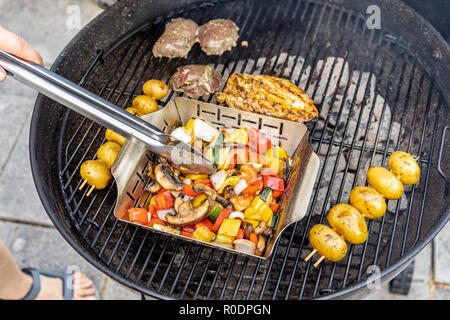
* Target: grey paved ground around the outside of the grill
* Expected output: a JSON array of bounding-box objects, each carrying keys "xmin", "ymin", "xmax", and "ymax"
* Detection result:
[{"xmin": 0, "ymin": 0, "xmax": 450, "ymax": 299}]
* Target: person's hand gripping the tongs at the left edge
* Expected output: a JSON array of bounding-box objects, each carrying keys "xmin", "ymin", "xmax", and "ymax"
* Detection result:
[{"xmin": 0, "ymin": 24, "xmax": 42, "ymax": 82}]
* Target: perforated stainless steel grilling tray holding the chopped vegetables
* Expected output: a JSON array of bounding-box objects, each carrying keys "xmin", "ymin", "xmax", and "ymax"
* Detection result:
[{"xmin": 111, "ymin": 98, "xmax": 320, "ymax": 259}]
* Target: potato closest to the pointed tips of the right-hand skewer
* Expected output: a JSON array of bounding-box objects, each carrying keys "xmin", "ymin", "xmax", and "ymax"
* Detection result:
[{"xmin": 309, "ymin": 224, "xmax": 347, "ymax": 261}]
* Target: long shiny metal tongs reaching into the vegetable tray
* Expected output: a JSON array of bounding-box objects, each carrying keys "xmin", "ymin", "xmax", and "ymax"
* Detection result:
[{"xmin": 0, "ymin": 50, "xmax": 215, "ymax": 174}]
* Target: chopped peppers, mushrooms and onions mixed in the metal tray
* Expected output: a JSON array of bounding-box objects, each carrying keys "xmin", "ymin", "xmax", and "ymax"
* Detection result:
[{"xmin": 129, "ymin": 119, "xmax": 289, "ymax": 255}]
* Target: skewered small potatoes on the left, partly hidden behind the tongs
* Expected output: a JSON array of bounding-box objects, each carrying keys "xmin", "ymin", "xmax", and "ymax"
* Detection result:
[{"xmin": 79, "ymin": 79, "xmax": 168, "ymax": 196}]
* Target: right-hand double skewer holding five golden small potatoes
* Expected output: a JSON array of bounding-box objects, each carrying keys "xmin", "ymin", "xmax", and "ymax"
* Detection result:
[{"xmin": 305, "ymin": 151, "xmax": 420, "ymax": 267}]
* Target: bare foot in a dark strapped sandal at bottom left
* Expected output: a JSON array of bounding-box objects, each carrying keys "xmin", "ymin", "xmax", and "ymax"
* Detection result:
[{"xmin": 31, "ymin": 272, "xmax": 96, "ymax": 300}]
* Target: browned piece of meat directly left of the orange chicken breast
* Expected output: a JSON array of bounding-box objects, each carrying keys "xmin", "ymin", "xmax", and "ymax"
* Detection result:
[{"xmin": 169, "ymin": 64, "xmax": 222, "ymax": 99}]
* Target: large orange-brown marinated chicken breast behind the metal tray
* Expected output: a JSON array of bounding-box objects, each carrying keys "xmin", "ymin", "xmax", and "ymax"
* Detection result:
[{"xmin": 216, "ymin": 73, "xmax": 318, "ymax": 122}]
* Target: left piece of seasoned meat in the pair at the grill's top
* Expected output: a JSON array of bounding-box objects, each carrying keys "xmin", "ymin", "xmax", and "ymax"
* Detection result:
[{"xmin": 153, "ymin": 18, "xmax": 198, "ymax": 58}]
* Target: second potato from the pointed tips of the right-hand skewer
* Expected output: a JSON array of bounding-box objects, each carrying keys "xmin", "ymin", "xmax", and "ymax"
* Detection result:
[{"xmin": 327, "ymin": 203, "xmax": 367, "ymax": 244}]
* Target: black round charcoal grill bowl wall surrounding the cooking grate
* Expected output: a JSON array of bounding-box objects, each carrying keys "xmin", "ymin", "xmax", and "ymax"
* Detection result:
[{"xmin": 30, "ymin": 0, "xmax": 450, "ymax": 299}]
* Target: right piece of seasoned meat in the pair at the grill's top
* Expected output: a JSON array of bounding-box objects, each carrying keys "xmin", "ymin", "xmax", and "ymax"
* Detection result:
[{"xmin": 197, "ymin": 19, "xmax": 239, "ymax": 55}]
